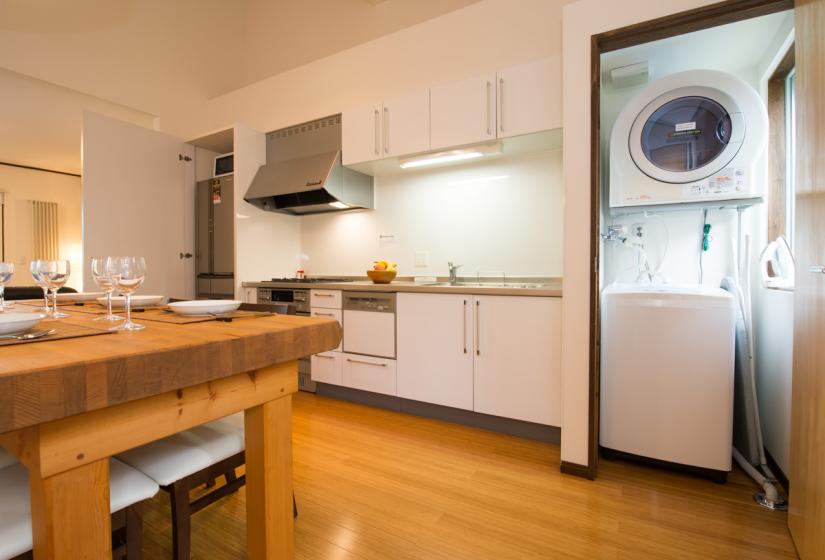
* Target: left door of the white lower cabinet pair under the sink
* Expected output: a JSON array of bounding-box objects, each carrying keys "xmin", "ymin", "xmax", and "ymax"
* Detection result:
[{"xmin": 397, "ymin": 293, "xmax": 473, "ymax": 410}]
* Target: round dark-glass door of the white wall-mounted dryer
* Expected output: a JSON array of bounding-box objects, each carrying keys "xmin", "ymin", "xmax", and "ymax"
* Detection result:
[{"xmin": 628, "ymin": 87, "xmax": 745, "ymax": 183}]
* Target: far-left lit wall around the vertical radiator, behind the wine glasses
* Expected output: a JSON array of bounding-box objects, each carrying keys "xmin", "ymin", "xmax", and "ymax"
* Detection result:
[{"xmin": 0, "ymin": 165, "xmax": 83, "ymax": 290}]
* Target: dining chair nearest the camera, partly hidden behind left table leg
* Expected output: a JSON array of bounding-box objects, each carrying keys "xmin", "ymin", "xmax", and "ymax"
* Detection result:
[{"xmin": 0, "ymin": 456, "xmax": 158, "ymax": 560}]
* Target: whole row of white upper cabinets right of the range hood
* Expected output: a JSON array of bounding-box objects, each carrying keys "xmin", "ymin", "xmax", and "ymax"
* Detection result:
[{"xmin": 343, "ymin": 56, "xmax": 562, "ymax": 165}]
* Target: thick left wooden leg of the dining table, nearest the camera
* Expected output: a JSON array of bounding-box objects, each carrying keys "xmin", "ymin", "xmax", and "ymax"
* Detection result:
[{"xmin": 29, "ymin": 459, "xmax": 112, "ymax": 560}]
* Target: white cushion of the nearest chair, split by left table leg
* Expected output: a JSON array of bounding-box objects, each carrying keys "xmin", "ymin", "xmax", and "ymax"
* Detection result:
[{"xmin": 0, "ymin": 459, "xmax": 158, "ymax": 560}]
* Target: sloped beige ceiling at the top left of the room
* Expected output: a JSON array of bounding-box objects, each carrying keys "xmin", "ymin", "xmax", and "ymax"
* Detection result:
[{"xmin": 0, "ymin": 0, "xmax": 479, "ymax": 172}]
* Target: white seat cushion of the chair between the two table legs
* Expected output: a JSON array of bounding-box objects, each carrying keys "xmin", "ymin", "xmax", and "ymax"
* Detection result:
[{"xmin": 118, "ymin": 413, "xmax": 244, "ymax": 486}]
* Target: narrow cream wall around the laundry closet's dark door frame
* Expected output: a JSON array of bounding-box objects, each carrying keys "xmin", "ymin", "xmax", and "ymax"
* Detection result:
[{"xmin": 561, "ymin": 0, "xmax": 713, "ymax": 465}]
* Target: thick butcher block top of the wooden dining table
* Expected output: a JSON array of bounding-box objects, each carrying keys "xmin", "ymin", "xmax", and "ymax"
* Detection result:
[{"xmin": 0, "ymin": 307, "xmax": 341, "ymax": 434}]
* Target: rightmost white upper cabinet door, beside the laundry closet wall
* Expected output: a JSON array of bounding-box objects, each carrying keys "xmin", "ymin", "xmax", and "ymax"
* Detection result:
[{"xmin": 496, "ymin": 56, "xmax": 562, "ymax": 138}]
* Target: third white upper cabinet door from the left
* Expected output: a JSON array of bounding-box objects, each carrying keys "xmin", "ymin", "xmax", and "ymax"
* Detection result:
[{"xmin": 430, "ymin": 74, "xmax": 496, "ymax": 150}]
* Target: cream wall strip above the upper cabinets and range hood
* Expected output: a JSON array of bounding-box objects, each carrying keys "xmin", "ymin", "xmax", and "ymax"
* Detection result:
[{"xmin": 179, "ymin": 0, "xmax": 569, "ymax": 138}]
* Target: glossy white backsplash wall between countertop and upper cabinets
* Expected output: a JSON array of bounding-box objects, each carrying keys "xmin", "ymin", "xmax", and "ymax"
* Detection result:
[{"xmin": 301, "ymin": 150, "xmax": 564, "ymax": 277}]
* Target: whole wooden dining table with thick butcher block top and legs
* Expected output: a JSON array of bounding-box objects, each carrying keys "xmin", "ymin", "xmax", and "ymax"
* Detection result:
[{"xmin": 0, "ymin": 306, "xmax": 341, "ymax": 560}]
